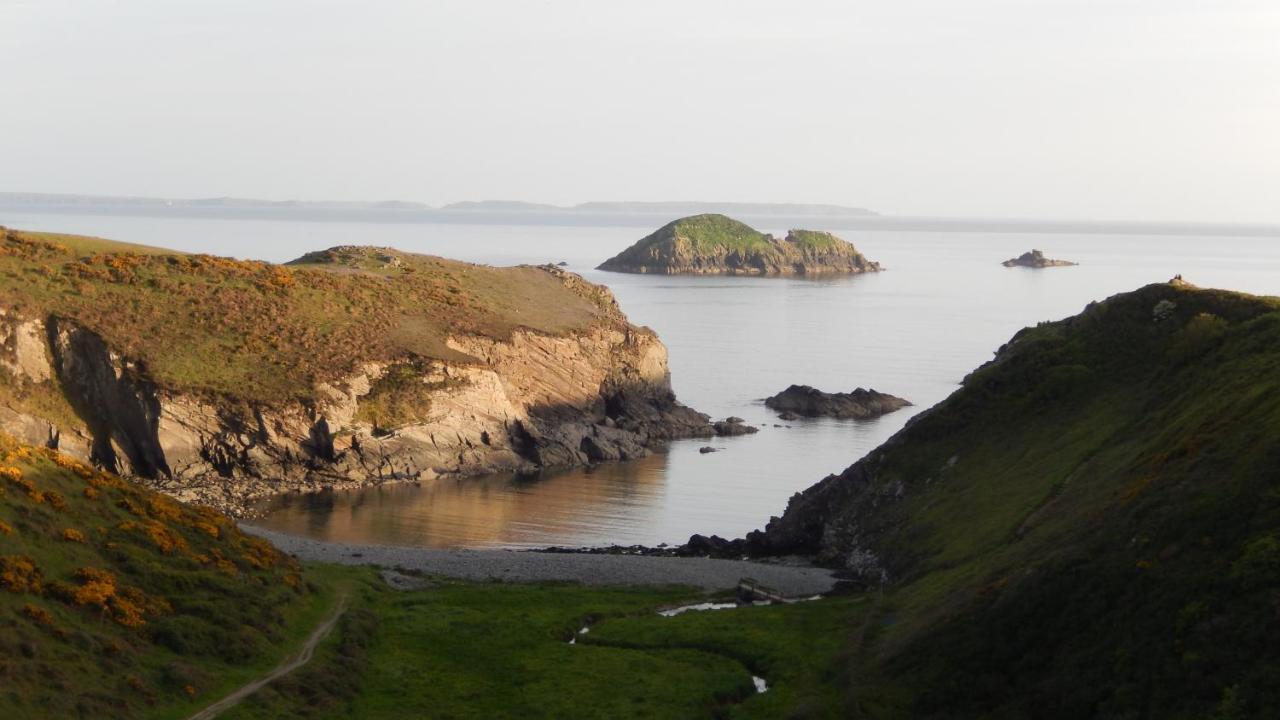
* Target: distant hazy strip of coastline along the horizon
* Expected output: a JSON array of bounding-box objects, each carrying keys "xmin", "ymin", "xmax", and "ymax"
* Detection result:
[{"xmin": 0, "ymin": 192, "xmax": 1280, "ymax": 238}]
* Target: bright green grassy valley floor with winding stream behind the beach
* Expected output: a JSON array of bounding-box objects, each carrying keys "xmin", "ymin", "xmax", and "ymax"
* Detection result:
[{"xmin": 227, "ymin": 570, "xmax": 864, "ymax": 720}]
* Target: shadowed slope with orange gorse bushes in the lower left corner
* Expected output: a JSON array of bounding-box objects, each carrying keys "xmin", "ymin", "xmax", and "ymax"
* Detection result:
[{"xmin": 0, "ymin": 427, "xmax": 329, "ymax": 719}]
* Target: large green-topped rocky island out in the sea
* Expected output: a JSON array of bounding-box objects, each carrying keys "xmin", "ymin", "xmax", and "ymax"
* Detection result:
[{"xmin": 596, "ymin": 214, "xmax": 881, "ymax": 275}]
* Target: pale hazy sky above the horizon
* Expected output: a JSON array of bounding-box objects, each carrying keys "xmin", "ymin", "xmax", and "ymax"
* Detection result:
[{"xmin": 0, "ymin": 0, "xmax": 1280, "ymax": 222}]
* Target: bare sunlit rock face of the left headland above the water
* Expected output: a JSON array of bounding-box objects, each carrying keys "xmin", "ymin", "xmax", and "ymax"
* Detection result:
[{"xmin": 0, "ymin": 249, "xmax": 716, "ymax": 512}]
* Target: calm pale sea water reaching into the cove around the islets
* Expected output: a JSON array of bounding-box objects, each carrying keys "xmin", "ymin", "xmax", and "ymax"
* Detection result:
[{"xmin": 0, "ymin": 213, "xmax": 1280, "ymax": 547}]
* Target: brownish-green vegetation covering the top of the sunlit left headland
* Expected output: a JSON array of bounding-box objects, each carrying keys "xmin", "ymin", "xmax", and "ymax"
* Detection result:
[{"xmin": 0, "ymin": 229, "xmax": 614, "ymax": 399}]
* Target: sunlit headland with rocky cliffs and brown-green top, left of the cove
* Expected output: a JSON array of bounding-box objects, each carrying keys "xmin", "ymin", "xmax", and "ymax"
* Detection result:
[{"xmin": 0, "ymin": 231, "xmax": 714, "ymax": 511}]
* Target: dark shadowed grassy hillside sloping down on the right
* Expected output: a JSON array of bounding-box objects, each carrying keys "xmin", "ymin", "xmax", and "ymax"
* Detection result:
[{"xmin": 749, "ymin": 282, "xmax": 1280, "ymax": 717}]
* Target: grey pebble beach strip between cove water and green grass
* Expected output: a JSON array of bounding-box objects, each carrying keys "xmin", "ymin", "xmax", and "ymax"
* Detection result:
[{"xmin": 241, "ymin": 523, "xmax": 836, "ymax": 597}]
